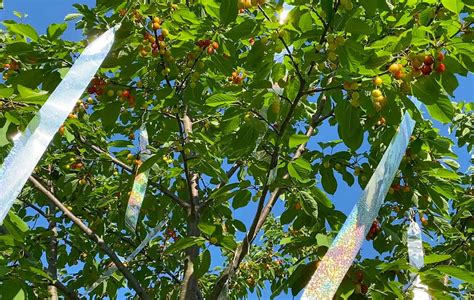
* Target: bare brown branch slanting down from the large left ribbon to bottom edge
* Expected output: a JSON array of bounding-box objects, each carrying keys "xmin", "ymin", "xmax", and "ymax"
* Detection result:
[{"xmin": 29, "ymin": 176, "xmax": 152, "ymax": 300}]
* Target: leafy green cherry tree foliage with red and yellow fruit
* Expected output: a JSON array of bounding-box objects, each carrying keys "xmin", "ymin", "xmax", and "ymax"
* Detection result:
[{"xmin": 0, "ymin": 0, "xmax": 474, "ymax": 299}]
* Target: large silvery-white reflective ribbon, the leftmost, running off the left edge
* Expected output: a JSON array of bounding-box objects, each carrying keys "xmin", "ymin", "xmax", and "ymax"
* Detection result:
[{"xmin": 0, "ymin": 25, "xmax": 120, "ymax": 224}]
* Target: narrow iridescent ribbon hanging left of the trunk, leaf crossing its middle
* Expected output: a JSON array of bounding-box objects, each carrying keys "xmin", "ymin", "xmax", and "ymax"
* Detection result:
[{"xmin": 125, "ymin": 125, "xmax": 151, "ymax": 231}]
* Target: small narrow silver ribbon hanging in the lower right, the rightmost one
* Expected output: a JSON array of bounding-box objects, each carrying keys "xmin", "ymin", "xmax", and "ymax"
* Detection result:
[{"xmin": 407, "ymin": 220, "xmax": 431, "ymax": 300}]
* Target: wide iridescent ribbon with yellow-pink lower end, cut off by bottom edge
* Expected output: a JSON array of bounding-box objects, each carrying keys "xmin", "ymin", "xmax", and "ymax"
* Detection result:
[{"xmin": 301, "ymin": 113, "xmax": 415, "ymax": 300}]
